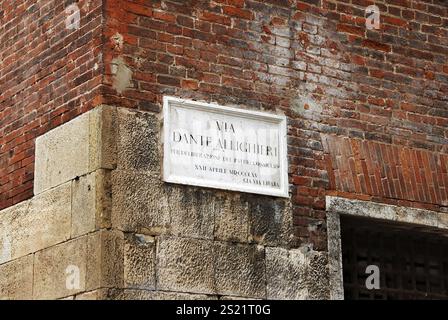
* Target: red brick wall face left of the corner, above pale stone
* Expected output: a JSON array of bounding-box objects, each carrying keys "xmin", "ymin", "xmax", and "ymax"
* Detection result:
[{"xmin": 0, "ymin": 0, "xmax": 103, "ymax": 209}]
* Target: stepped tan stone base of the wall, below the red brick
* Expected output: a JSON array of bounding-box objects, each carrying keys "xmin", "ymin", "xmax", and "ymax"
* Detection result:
[{"xmin": 0, "ymin": 106, "xmax": 329, "ymax": 299}]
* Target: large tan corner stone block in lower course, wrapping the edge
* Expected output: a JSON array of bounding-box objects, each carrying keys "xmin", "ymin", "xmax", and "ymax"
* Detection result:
[{"xmin": 34, "ymin": 230, "xmax": 123, "ymax": 299}]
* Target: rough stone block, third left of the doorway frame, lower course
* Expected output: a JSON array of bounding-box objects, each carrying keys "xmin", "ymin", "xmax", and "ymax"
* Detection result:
[{"xmin": 156, "ymin": 238, "xmax": 216, "ymax": 294}]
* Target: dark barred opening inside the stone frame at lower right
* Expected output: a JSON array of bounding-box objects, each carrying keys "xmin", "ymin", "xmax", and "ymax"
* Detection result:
[{"xmin": 341, "ymin": 216, "xmax": 448, "ymax": 300}]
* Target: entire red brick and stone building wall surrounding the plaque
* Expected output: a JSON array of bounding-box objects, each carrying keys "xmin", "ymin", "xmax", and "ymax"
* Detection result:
[{"xmin": 0, "ymin": 0, "xmax": 448, "ymax": 299}]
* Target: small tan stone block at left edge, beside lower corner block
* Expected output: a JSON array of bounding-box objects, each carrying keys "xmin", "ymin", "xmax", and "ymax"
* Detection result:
[{"xmin": 0, "ymin": 254, "xmax": 33, "ymax": 300}]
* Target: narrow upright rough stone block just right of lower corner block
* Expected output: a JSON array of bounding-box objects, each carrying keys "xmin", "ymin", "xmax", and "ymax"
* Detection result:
[{"xmin": 124, "ymin": 234, "xmax": 156, "ymax": 290}]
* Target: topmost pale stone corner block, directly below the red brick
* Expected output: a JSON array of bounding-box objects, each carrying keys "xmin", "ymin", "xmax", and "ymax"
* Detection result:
[{"xmin": 34, "ymin": 106, "xmax": 116, "ymax": 194}]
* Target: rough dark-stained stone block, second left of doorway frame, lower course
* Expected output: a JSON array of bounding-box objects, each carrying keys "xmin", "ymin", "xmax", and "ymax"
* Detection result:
[{"xmin": 214, "ymin": 242, "xmax": 266, "ymax": 298}]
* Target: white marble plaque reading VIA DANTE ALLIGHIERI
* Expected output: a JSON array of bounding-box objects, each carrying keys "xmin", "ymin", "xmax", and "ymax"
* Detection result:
[{"xmin": 163, "ymin": 97, "xmax": 288, "ymax": 197}]
